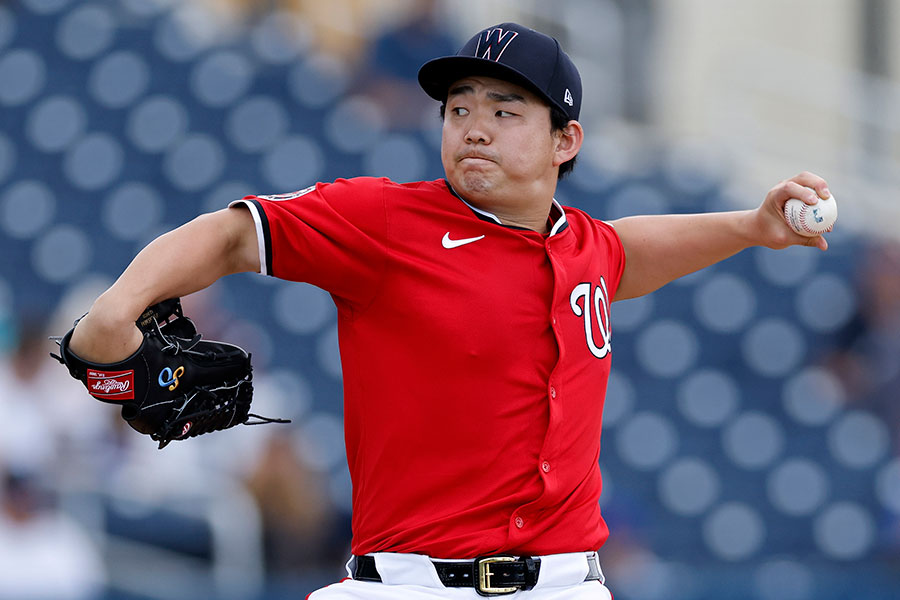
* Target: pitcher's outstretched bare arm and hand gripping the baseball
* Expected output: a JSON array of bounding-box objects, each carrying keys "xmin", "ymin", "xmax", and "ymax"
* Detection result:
[{"xmin": 611, "ymin": 173, "xmax": 830, "ymax": 300}]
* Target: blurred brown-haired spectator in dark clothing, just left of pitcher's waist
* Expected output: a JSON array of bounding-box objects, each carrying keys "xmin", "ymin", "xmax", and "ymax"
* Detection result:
[{"xmin": 246, "ymin": 431, "xmax": 349, "ymax": 575}]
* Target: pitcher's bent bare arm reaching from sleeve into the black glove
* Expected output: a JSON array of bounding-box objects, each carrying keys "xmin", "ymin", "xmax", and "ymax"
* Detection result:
[{"xmin": 70, "ymin": 205, "xmax": 260, "ymax": 363}]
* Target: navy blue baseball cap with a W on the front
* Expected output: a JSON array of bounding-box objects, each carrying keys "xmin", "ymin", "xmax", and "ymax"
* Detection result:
[{"xmin": 419, "ymin": 23, "xmax": 581, "ymax": 120}]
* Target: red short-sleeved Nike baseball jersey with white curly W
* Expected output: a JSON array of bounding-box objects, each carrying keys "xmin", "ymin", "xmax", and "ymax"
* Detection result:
[{"xmin": 232, "ymin": 178, "xmax": 625, "ymax": 558}]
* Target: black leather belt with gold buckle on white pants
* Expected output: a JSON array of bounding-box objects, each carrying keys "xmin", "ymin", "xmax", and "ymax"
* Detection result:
[{"xmin": 351, "ymin": 555, "xmax": 603, "ymax": 596}]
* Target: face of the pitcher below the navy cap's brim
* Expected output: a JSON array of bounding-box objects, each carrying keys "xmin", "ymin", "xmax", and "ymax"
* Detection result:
[{"xmin": 441, "ymin": 76, "xmax": 558, "ymax": 210}]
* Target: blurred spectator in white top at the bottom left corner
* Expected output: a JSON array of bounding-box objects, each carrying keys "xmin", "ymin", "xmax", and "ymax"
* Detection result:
[{"xmin": 0, "ymin": 469, "xmax": 105, "ymax": 600}]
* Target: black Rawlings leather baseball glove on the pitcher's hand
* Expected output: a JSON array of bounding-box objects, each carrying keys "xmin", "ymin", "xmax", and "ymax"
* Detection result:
[{"xmin": 51, "ymin": 298, "xmax": 290, "ymax": 450}]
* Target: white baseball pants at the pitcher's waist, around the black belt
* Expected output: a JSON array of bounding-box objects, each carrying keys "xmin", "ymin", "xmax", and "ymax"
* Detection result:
[{"xmin": 307, "ymin": 552, "xmax": 612, "ymax": 600}]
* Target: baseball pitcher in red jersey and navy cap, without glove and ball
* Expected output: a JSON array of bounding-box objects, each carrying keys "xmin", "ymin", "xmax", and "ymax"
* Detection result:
[{"xmin": 70, "ymin": 23, "xmax": 829, "ymax": 600}]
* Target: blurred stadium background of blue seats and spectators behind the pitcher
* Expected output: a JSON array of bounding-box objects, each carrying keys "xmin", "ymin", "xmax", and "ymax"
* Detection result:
[{"xmin": 0, "ymin": 0, "xmax": 900, "ymax": 600}]
